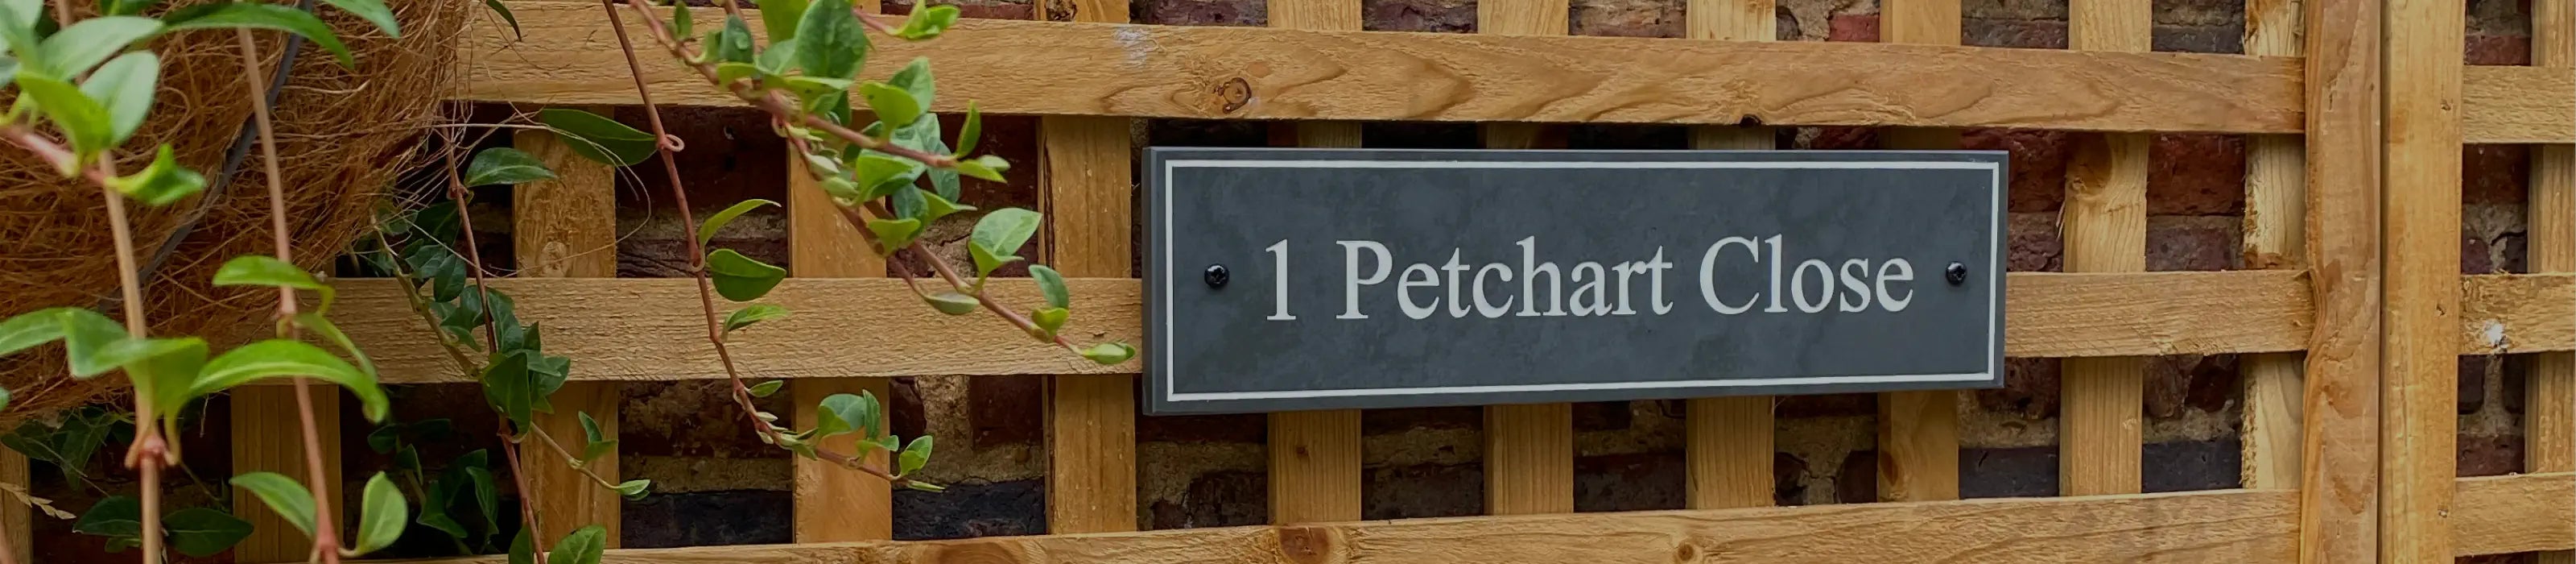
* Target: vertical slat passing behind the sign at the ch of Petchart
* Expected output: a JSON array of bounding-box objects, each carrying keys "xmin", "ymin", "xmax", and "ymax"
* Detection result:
[{"xmin": 1476, "ymin": 0, "xmax": 1574, "ymax": 515}]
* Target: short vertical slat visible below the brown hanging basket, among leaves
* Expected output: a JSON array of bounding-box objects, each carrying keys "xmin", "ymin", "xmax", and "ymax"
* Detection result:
[{"xmin": 232, "ymin": 384, "xmax": 353, "ymax": 564}]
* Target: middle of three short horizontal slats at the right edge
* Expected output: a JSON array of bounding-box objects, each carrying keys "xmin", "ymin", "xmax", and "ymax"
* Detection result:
[{"xmin": 2460, "ymin": 273, "xmax": 2576, "ymax": 355}]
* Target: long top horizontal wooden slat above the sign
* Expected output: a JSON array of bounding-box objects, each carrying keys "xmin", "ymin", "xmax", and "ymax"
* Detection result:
[{"xmin": 459, "ymin": 0, "xmax": 2303, "ymax": 134}]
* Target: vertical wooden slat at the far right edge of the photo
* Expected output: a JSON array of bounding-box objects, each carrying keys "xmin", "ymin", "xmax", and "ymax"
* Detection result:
[{"xmin": 2522, "ymin": 0, "xmax": 2576, "ymax": 564}]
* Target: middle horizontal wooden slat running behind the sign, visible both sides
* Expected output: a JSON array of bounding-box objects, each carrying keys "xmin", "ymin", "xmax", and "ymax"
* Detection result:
[{"xmin": 312, "ymin": 271, "xmax": 2310, "ymax": 384}]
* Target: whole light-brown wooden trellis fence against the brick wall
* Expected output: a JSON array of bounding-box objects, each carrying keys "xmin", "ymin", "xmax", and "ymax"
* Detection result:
[{"xmin": 13, "ymin": 0, "xmax": 2576, "ymax": 564}]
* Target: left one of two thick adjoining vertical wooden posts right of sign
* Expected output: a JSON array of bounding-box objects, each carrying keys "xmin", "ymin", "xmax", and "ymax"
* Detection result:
[{"xmin": 2297, "ymin": 0, "xmax": 2383, "ymax": 556}]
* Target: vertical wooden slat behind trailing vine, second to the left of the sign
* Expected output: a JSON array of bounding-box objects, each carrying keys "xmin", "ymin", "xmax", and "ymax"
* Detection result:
[{"xmin": 782, "ymin": 155, "xmax": 894, "ymax": 543}]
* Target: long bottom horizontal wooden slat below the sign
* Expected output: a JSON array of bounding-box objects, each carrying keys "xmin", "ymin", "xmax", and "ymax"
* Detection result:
[{"xmin": 368, "ymin": 489, "xmax": 2297, "ymax": 564}]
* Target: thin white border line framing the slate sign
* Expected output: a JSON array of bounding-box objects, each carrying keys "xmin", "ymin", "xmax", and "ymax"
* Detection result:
[{"xmin": 1154, "ymin": 160, "xmax": 2004, "ymax": 402}]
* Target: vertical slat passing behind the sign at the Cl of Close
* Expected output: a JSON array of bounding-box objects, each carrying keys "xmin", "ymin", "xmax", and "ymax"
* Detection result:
[{"xmin": 1682, "ymin": 0, "xmax": 1780, "ymax": 510}]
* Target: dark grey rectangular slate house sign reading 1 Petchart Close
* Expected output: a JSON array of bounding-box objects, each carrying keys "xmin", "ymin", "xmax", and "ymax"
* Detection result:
[{"xmin": 1144, "ymin": 147, "xmax": 2007, "ymax": 415}]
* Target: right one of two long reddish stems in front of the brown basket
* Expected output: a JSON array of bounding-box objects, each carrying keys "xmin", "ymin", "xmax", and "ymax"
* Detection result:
[{"xmin": 232, "ymin": 28, "xmax": 340, "ymax": 564}]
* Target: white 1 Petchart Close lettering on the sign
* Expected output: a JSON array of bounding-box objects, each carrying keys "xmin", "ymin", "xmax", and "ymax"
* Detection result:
[{"xmin": 1288, "ymin": 234, "xmax": 1914, "ymax": 322}]
